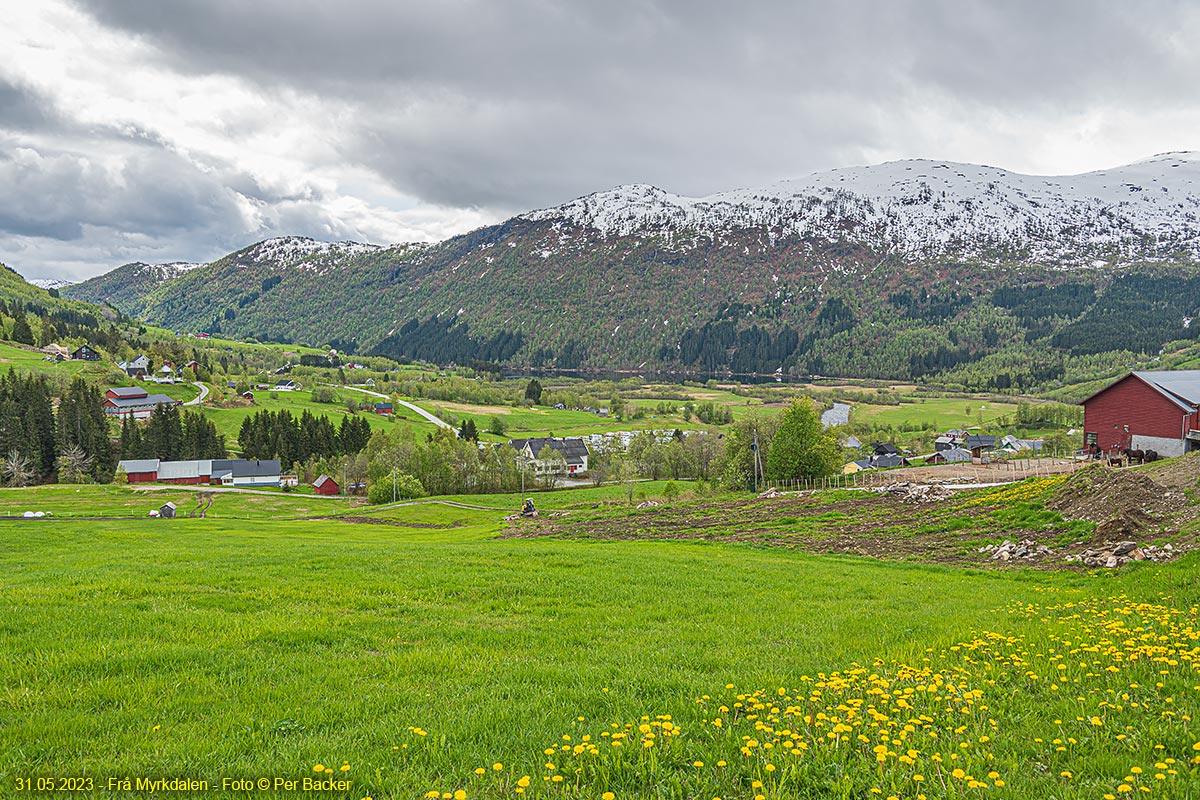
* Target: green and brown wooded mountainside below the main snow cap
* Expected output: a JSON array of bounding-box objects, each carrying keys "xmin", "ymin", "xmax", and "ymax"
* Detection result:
[{"xmin": 67, "ymin": 226, "xmax": 1200, "ymax": 391}]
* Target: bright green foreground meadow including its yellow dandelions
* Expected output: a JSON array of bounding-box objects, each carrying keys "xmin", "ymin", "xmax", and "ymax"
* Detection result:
[{"xmin": 0, "ymin": 487, "xmax": 1200, "ymax": 800}]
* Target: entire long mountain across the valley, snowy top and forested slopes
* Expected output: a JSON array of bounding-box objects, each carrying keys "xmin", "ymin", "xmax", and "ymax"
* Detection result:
[{"xmin": 64, "ymin": 154, "xmax": 1200, "ymax": 385}]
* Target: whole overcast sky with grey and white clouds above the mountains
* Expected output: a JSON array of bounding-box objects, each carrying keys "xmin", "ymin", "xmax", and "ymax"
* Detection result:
[{"xmin": 0, "ymin": 0, "xmax": 1200, "ymax": 279}]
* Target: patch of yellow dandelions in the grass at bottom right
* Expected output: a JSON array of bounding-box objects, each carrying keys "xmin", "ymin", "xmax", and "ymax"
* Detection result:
[{"xmin": 415, "ymin": 596, "xmax": 1200, "ymax": 800}]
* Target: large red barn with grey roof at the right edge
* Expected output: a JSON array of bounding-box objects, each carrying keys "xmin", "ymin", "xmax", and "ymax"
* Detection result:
[{"xmin": 1084, "ymin": 369, "xmax": 1200, "ymax": 456}]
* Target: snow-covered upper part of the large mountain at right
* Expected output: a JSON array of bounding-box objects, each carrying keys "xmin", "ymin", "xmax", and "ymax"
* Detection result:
[{"xmin": 523, "ymin": 152, "xmax": 1200, "ymax": 265}]
